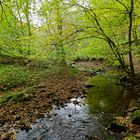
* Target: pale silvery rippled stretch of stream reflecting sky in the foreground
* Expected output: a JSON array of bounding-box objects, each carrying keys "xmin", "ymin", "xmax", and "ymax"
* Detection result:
[{"xmin": 17, "ymin": 98, "xmax": 118, "ymax": 140}]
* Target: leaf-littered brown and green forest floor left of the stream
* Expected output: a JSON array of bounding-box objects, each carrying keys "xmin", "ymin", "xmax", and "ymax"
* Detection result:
[{"xmin": 0, "ymin": 56, "xmax": 140, "ymax": 140}]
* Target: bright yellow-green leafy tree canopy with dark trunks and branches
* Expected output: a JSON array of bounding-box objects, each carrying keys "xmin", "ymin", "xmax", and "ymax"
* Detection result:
[{"xmin": 0, "ymin": 0, "xmax": 140, "ymax": 74}]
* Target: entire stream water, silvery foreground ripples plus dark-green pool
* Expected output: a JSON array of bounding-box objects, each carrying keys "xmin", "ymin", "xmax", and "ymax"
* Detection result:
[{"xmin": 17, "ymin": 76, "xmax": 130, "ymax": 140}]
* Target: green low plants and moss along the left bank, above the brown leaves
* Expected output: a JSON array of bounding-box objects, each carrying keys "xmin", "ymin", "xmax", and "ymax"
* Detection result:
[{"xmin": 0, "ymin": 64, "xmax": 78, "ymax": 103}]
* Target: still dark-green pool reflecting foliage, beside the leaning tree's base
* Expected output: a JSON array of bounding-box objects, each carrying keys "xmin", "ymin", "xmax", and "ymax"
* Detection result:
[{"xmin": 86, "ymin": 76, "xmax": 131, "ymax": 115}]
